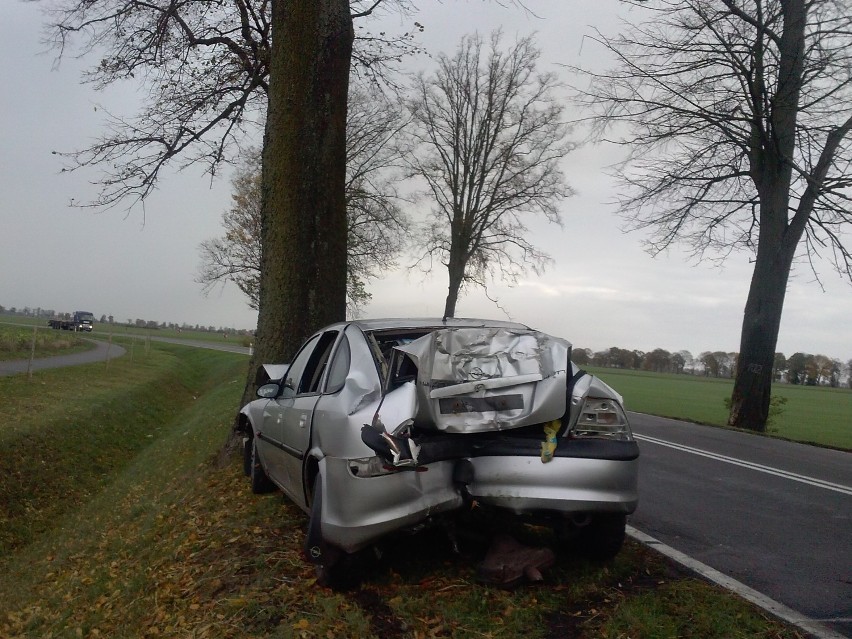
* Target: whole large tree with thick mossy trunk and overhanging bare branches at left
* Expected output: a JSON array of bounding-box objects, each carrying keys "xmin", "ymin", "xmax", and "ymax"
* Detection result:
[{"xmin": 42, "ymin": 0, "xmax": 420, "ymax": 412}]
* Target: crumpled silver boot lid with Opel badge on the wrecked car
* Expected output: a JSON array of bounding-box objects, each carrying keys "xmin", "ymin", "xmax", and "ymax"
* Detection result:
[{"xmin": 396, "ymin": 327, "xmax": 571, "ymax": 433}]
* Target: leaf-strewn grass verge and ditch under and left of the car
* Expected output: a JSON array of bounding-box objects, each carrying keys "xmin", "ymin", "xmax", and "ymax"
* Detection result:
[{"xmin": 0, "ymin": 344, "xmax": 802, "ymax": 639}]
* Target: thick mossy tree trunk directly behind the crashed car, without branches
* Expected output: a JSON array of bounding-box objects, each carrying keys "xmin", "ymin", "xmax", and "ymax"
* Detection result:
[{"xmin": 238, "ymin": 0, "xmax": 354, "ymax": 410}]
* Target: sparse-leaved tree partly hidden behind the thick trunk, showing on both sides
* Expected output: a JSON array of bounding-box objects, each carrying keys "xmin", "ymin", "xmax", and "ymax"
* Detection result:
[{"xmin": 196, "ymin": 89, "xmax": 408, "ymax": 313}]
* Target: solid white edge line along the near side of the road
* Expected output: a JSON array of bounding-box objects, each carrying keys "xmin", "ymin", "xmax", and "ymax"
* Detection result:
[{"xmin": 627, "ymin": 526, "xmax": 846, "ymax": 639}]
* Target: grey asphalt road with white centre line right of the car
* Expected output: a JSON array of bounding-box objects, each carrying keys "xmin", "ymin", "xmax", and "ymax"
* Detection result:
[{"xmin": 630, "ymin": 413, "xmax": 852, "ymax": 637}]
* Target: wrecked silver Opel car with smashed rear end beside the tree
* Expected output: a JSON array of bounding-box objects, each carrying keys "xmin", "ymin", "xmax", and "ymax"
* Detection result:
[{"xmin": 238, "ymin": 319, "xmax": 639, "ymax": 581}]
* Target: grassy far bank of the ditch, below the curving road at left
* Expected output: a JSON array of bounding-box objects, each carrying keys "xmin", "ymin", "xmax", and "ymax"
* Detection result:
[{"xmin": 0, "ymin": 345, "xmax": 250, "ymax": 555}]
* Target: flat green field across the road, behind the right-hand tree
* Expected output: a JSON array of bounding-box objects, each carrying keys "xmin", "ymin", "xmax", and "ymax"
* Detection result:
[{"xmin": 586, "ymin": 367, "xmax": 852, "ymax": 450}]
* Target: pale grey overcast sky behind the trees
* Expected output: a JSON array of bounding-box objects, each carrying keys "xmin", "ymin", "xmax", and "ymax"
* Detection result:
[{"xmin": 0, "ymin": 0, "xmax": 852, "ymax": 362}]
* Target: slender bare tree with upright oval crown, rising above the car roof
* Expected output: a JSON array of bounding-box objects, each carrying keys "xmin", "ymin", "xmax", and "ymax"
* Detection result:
[{"xmin": 407, "ymin": 31, "xmax": 571, "ymax": 317}]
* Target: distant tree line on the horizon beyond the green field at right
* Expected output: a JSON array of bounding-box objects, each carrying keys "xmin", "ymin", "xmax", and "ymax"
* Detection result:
[{"xmin": 571, "ymin": 346, "xmax": 852, "ymax": 388}]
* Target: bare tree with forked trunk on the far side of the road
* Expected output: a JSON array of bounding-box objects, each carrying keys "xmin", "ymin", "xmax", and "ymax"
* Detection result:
[{"xmin": 582, "ymin": 0, "xmax": 852, "ymax": 430}]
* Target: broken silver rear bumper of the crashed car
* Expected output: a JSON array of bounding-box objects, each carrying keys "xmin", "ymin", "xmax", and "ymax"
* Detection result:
[{"xmin": 320, "ymin": 444, "xmax": 638, "ymax": 552}]
